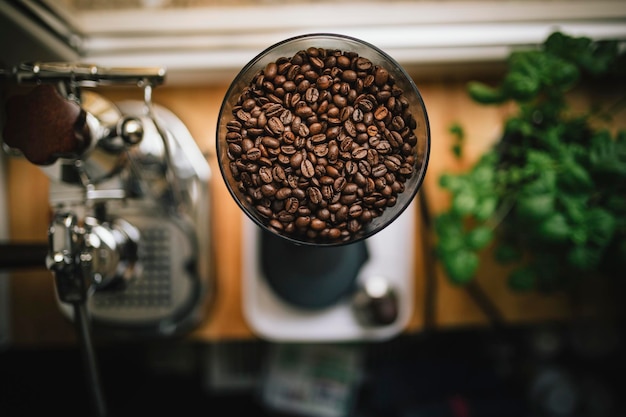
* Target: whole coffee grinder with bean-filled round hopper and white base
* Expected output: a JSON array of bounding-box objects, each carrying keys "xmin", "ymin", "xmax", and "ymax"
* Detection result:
[{"xmin": 217, "ymin": 33, "xmax": 430, "ymax": 341}]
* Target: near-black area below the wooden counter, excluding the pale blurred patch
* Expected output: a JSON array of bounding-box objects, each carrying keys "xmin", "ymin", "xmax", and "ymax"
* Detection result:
[{"xmin": 0, "ymin": 321, "xmax": 626, "ymax": 417}]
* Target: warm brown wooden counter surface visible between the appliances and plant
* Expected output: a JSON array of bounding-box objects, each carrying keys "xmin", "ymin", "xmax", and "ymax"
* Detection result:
[{"xmin": 7, "ymin": 82, "xmax": 578, "ymax": 346}]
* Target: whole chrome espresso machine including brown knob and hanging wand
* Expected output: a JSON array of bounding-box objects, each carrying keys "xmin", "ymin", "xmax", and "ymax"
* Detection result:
[{"xmin": 2, "ymin": 62, "xmax": 214, "ymax": 416}]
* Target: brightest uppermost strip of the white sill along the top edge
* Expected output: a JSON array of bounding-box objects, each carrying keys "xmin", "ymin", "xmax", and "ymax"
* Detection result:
[{"xmin": 75, "ymin": 0, "xmax": 626, "ymax": 35}]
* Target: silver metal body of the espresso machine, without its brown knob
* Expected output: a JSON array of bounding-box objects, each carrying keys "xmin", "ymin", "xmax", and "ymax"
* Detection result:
[{"xmin": 4, "ymin": 63, "xmax": 213, "ymax": 337}]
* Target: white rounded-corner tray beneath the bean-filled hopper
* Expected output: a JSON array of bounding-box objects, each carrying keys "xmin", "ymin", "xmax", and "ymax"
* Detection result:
[{"xmin": 241, "ymin": 200, "xmax": 416, "ymax": 342}]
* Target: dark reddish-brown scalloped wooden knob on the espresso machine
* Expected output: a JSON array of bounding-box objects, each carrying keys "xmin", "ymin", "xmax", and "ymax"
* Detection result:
[{"xmin": 3, "ymin": 84, "xmax": 91, "ymax": 165}]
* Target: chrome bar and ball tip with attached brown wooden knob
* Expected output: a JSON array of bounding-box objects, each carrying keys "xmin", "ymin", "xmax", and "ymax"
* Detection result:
[{"xmin": 0, "ymin": 62, "xmax": 161, "ymax": 165}]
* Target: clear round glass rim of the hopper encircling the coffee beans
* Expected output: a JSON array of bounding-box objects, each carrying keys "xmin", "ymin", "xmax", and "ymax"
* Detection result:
[{"xmin": 215, "ymin": 32, "xmax": 431, "ymax": 247}]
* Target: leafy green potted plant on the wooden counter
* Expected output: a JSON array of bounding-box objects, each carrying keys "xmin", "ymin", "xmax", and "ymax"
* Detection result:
[{"xmin": 435, "ymin": 32, "xmax": 626, "ymax": 291}]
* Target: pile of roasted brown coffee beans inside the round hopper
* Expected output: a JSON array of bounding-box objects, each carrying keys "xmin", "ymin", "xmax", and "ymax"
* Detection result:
[{"xmin": 226, "ymin": 47, "xmax": 418, "ymax": 243}]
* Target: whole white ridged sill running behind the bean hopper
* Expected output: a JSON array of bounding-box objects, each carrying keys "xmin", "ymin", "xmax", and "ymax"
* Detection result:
[{"xmin": 24, "ymin": 0, "xmax": 626, "ymax": 84}]
